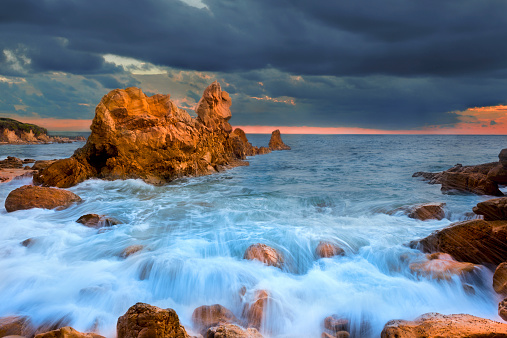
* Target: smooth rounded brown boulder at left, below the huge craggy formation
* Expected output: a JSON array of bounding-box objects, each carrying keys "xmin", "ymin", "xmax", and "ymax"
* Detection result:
[{"xmin": 5, "ymin": 185, "xmax": 81, "ymax": 212}]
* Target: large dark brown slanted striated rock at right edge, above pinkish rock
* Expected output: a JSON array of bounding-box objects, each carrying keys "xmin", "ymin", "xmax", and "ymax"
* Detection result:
[{"xmin": 410, "ymin": 219, "xmax": 507, "ymax": 265}]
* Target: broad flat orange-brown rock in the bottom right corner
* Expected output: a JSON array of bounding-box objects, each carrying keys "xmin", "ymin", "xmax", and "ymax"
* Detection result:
[{"xmin": 381, "ymin": 313, "xmax": 507, "ymax": 338}]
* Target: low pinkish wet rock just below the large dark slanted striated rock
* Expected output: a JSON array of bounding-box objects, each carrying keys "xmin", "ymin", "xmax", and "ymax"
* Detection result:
[{"xmin": 409, "ymin": 252, "xmax": 476, "ymax": 280}]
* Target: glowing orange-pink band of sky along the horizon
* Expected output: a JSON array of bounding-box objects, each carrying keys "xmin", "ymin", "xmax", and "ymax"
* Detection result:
[{"xmin": 9, "ymin": 105, "xmax": 507, "ymax": 135}]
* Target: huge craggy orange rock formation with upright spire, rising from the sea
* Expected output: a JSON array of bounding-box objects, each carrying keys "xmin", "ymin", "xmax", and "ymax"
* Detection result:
[{"xmin": 34, "ymin": 81, "xmax": 278, "ymax": 188}]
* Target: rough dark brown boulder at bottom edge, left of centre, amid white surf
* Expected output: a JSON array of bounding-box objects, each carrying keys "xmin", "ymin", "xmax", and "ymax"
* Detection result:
[{"xmin": 116, "ymin": 303, "xmax": 189, "ymax": 338}]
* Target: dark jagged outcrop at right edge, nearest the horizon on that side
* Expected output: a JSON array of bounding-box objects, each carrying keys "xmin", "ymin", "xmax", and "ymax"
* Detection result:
[{"xmin": 412, "ymin": 149, "xmax": 507, "ymax": 196}]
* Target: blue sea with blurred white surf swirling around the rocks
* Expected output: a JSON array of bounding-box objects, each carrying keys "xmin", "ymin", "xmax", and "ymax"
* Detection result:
[{"xmin": 0, "ymin": 135, "xmax": 507, "ymax": 337}]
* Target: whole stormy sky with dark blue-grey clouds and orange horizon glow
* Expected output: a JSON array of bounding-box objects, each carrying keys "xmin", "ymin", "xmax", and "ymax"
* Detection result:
[{"xmin": 0, "ymin": 0, "xmax": 507, "ymax": 134}]
